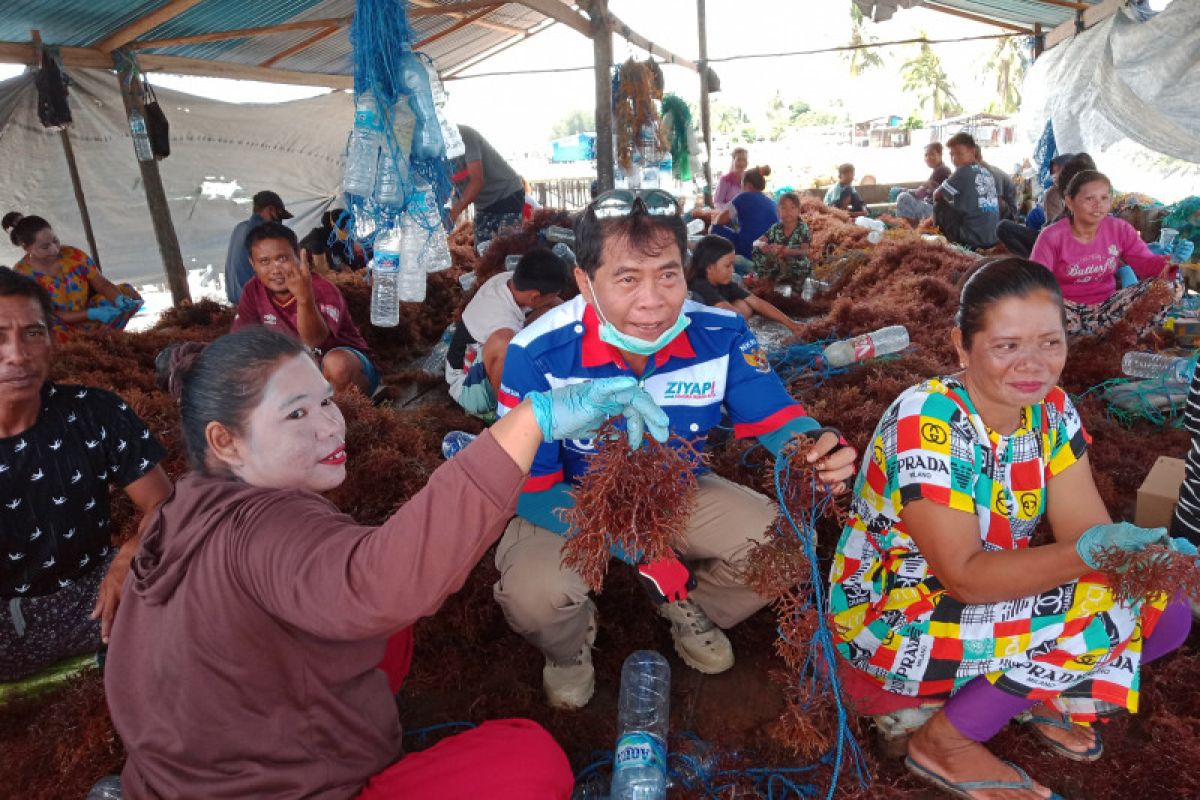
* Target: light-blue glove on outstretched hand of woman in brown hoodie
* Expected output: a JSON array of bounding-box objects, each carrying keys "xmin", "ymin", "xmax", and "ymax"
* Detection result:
[{"xmin": 529, "ymin": 375, "xmax": 670, "ymax": 450}]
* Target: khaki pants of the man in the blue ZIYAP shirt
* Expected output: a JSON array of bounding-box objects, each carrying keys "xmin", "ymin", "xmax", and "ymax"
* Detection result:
[{"xmin": 494, "ymin": 474, "xmax": 776, "ymax": 661}]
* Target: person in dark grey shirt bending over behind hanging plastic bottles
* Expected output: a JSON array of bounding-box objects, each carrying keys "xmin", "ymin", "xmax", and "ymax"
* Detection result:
[{"xmin": 450, "ymin": 125, "xmax": 524, "ymax": 247}]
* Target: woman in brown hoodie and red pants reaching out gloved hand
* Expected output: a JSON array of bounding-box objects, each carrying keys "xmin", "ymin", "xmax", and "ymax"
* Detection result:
[{"xmin": 104, "ymin": 327, "xmax": 667, "ymax": 800}]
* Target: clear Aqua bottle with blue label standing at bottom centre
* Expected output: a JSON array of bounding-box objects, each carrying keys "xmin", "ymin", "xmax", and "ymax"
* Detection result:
[{"xmin": 610, "ymin": 650, "xmax": 671, "ymax": 800}]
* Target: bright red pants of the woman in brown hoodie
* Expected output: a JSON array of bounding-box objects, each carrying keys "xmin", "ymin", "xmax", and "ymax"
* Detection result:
[{"xmin": 356, "ymin": 720, "xmax": 575, "ymax": 800}]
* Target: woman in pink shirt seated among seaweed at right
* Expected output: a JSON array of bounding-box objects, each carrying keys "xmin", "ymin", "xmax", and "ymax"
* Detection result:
[{"xmin": 1030, "ymin": 169, "xmax": 1170, "ymax": 336}]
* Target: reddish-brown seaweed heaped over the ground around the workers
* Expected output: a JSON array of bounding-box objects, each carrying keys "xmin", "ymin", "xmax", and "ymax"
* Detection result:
[{"xmin": 0, "ymin": 209, "xmax": 1200, "ymax": 800}]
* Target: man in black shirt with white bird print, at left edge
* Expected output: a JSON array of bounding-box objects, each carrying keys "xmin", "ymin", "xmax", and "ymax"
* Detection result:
[{"xmin": 0, "ymin": 267, "xmax": 170, "ymax": 682}]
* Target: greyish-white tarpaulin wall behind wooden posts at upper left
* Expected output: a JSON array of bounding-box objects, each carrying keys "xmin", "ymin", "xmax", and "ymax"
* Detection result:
[{"xmin": 0, "ymin": 70, "xmax": 354, "ymax": 283}]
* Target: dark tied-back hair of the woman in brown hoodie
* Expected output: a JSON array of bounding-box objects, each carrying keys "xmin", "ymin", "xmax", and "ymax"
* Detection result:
[{"xmin": 166, "ymin": 325, "xmax": 308, "ymax": 475}]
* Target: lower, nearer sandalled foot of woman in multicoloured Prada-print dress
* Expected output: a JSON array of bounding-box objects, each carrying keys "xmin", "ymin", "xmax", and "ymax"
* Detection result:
[{"xmin": 908, "ymin": 711, "xmax": 1052, "ymax": 800}]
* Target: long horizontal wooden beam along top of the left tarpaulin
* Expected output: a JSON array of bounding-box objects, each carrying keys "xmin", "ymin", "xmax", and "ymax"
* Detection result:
[{"xmin": 0, "ymin": 42, "xmax": 354, "ymax": 89}]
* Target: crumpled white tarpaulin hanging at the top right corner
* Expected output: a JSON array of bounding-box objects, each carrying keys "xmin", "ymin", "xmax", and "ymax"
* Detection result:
[{"xmin": 1021, "ymin": 0, "xmax": 1200, "ymax": 162}]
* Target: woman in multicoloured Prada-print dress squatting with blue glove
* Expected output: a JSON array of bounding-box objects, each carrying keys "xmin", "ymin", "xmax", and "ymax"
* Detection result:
[{"xmin": 830, "ymin": 258, "xmax": 1192, "ymax": 800}]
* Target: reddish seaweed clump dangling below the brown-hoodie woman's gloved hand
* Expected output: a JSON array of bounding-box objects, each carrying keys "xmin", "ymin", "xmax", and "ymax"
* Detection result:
[{"xmin": 563, "ymin": 422, "xmax": 703, "ymax": 591}]
